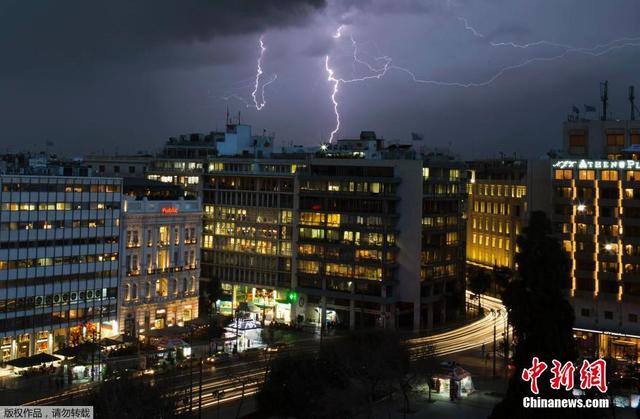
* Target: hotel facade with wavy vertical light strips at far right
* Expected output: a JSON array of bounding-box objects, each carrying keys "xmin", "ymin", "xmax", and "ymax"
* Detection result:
[{"xmin": 552, "ymin": 159, "xmax": 640, "ymax": 362}]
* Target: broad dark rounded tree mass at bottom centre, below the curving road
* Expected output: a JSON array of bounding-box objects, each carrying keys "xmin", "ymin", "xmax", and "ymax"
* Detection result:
[{"xmin": 257, "ymin": 330, "xmax": 410, "ymax": 419}]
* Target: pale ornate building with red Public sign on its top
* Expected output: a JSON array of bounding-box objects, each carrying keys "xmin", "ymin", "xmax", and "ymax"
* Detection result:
[{"xmin": 118, "ymin": 195, "xmax": 202, "ymax": 336}]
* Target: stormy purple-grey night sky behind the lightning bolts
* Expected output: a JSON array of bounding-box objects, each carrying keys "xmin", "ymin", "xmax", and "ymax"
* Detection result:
[{"xmin": 0, "ymin": 0, "xmax": 640, "ymax": 157}]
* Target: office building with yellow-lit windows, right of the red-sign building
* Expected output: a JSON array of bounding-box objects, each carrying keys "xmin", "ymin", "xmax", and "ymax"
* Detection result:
[{"xmin": 202, "ymin": 157, "xmax": 298, "ymax": 322}]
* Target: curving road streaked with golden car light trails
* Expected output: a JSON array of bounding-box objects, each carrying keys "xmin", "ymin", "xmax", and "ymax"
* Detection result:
[{"xmin": 26, "ymin": 293, "xmax": 506, "ymax": 410}]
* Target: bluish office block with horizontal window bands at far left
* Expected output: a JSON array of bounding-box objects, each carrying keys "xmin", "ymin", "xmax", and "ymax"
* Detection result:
[{"xmin": 0, "ymin": 175, "xmax": 122, "ymax": 361}]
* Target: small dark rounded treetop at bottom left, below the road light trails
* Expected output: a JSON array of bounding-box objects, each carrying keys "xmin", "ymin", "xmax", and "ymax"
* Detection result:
[{"xmin": 90, "ymin": 377, "xmax": 176, "ymax": 419}]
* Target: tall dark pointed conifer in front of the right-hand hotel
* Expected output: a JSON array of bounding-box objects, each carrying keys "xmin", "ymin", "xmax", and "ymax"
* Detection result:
[{"xmin": 490, "ymin": 212, "xmax": 587, "ymax": 419}]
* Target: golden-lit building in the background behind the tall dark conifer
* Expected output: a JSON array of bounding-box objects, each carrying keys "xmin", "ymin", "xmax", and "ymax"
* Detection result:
[{"xmin": 467, "ymin": 157, "xmax": 551, "ymax": 270}]
